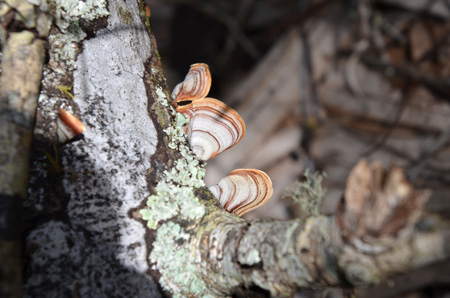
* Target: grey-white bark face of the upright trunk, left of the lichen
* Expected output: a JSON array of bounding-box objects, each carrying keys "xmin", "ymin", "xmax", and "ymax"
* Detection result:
[{"xmin": 24, "ymin": 1, "xmax": 159, "ymax": 297}]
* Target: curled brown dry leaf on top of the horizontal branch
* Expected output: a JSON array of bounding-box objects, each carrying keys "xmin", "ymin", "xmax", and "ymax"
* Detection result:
[{"xmin": 338, "ymin": 160, "xmax": 431, "ymax": 240}]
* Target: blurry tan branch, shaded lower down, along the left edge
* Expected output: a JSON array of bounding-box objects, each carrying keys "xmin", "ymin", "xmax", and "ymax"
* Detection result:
[{"xmin": 0, "ymin": 3, "xmax": 49, "ymax": 297}]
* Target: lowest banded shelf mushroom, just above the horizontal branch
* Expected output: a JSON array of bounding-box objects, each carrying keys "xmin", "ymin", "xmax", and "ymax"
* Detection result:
[{"xmin": 209, "ymin": 169, "xmax": 273, "ymax": 215}]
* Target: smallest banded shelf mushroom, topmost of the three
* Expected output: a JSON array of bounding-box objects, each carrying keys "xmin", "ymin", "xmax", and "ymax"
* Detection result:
[{"xmin": 172, "ymin": 63, "xmax": 211, "ymax": 104}]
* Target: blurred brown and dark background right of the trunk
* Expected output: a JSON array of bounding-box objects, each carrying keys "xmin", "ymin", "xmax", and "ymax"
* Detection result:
[{"xmin": 147, "ymin": 0, "xmax": 450, "ymax": 297}]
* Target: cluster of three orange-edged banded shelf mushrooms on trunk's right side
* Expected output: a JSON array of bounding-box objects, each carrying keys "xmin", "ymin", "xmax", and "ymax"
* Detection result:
[{"xmin": 172, "ymin": 63, "xmax": 273, "ymax": 215}]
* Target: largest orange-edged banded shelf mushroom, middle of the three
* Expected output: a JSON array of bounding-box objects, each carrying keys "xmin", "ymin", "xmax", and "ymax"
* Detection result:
[{"xmin": 177, "ymin": 98, "xmax": 245, "ymax": 160}]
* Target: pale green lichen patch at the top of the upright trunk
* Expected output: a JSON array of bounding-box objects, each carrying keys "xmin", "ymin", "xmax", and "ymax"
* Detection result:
[{"xmin": 49, "ymin": 0, "xmax": 109, "ymax": 66}]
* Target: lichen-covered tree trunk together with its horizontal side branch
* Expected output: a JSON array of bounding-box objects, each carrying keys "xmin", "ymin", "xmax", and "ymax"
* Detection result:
[{"xmin": 2, "ymin": 0, "xmax": 450, "ymax": 297}]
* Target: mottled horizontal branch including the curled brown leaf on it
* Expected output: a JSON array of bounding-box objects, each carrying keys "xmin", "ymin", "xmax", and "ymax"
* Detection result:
[{"xmin": 199, "ymin": 160, "xmax": 450, "ymax": 297}]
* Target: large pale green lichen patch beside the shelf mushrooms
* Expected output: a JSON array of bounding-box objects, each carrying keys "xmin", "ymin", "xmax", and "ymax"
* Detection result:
[{"xmin": 141, "ymin": 87, "xmax": 214, "ymax": 297}]
